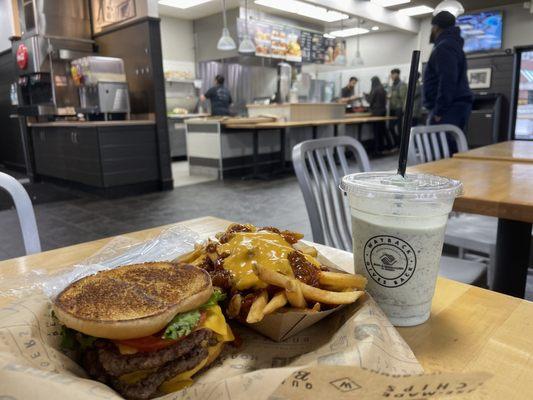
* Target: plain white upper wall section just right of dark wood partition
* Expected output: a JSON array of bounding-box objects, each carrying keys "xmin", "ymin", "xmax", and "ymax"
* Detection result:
[{"xmin": 161, "ymin": 15, "xmax": 195, "ymax": 74}]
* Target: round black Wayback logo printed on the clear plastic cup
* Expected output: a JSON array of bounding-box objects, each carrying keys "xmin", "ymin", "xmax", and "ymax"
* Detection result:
[{"xmin": 364, "ymin": 235, "xmax": 416, "ymax": 287}]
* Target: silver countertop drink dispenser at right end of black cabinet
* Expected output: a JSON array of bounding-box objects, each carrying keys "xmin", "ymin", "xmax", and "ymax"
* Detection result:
[{"xmin": 71, "ymin": 56, "xmax": 130, "ymax": 120}]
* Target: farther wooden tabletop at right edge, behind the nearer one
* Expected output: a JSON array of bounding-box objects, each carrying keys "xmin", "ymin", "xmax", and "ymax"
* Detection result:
[{"xmin": 453, "ymin": 140, "xmax": 533, "ymax": 163}]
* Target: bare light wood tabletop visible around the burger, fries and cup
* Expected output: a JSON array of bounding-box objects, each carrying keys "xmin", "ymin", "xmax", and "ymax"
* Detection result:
[{"xmin": 0, "ymin": 217, "xmax": 533, "ymax": 400}]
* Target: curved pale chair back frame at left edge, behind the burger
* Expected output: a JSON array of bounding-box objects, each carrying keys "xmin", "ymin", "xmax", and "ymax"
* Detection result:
[{"xmin": 0, "ymin": 172, "xmax": 41, "ymax": 254}]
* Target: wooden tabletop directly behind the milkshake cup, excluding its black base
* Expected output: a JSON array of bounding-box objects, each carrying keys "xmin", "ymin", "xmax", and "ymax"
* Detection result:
[{"xmin": 408, "ymin": 158, "xmax": 533, "ymax": 222}]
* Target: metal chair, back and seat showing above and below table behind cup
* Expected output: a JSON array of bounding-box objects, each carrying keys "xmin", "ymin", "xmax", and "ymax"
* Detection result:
[{"xmin": 409, "ymin": 125, "xmax": 498, "ymax": 287}]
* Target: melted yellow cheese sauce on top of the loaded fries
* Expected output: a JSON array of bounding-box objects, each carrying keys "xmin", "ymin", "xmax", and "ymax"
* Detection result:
[{"xmin": 219, "ymin": 231, "xmax": 320, "ymax": 290}]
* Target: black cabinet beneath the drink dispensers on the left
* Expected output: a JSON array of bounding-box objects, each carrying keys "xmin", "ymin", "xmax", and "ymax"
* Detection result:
[{"xmin": 31, "ymin": 125, "xmax": 159, "ymax": 188}]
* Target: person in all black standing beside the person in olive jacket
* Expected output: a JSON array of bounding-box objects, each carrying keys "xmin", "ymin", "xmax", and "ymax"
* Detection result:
[{"xmin": 365, "ymin": 76, "xmax": 394, "ymax": 155}]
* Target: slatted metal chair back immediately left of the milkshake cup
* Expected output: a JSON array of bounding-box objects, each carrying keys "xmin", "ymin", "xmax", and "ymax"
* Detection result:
[{"xmin": 292, "ymin": 136, "xmax": 370, "ymax": 251}]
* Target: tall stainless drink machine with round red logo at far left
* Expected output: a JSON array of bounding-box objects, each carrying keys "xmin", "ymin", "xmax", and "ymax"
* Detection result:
[{"xmin": 12, "ymin": 0, "xmax": 94, "ymax": 116}]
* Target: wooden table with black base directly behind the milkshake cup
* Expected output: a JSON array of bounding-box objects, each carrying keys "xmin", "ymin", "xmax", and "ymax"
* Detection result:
[{"xmin": 409, "ymin": 158, "xmax": 533, "ymax": 298}]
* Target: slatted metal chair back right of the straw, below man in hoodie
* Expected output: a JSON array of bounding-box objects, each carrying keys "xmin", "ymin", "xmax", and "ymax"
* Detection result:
[{"xmin": 409, "ymin": 124, "xmax": 468, "ymax": 165}]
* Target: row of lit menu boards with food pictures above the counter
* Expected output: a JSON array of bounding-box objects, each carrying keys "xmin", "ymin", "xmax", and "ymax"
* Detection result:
[{"xmin": 237, "ymin": 19, "xmax": 346, "ymax": 65}]
